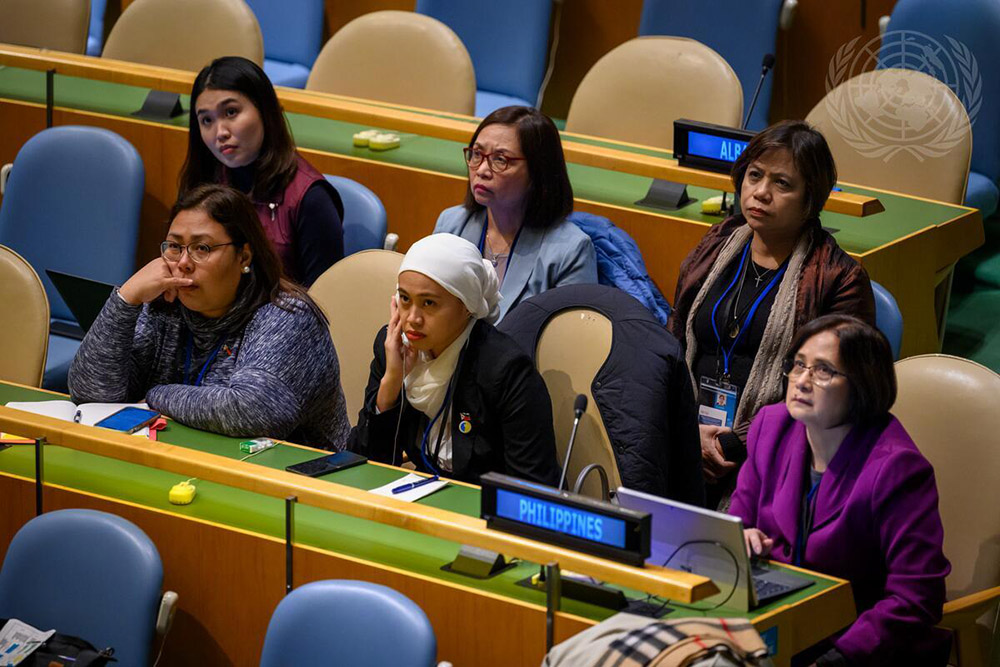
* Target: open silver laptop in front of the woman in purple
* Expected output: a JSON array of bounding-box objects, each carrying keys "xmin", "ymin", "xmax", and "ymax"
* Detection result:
[{"xmin": 615, "ymin": 487, "xmax": 812, "ymax": 612}]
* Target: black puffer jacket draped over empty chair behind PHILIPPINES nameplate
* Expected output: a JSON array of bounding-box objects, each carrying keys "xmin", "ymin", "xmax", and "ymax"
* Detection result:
[{"xmin": 498, "ymin": 285, "xmax": 705, "ymax": 505}]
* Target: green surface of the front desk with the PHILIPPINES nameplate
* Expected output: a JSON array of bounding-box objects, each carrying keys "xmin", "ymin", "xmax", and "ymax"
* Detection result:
[{"xmin": 0, "ymin": 383, "xmax": 836, "ymax": 621}]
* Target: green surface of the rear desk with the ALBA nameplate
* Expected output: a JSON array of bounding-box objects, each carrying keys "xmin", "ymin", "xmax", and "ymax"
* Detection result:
[{"xmin": 0, "ymin": 66, "xmax": 964, "ymax": 254}]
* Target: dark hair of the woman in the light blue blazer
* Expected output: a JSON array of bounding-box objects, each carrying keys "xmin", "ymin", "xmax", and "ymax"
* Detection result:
[{"xmin": 465, "ymin": 106, "xmax": 573, "ymax": 227}]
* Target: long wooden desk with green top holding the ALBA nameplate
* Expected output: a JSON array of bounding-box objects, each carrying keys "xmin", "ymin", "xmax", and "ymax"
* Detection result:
[{"xmin": 0, "ymin": 47, "xmax": 983, "ymax": 355}]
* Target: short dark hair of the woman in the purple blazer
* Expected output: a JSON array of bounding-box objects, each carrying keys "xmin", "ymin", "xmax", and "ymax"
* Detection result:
[{"xmin": 786, "ymin": 314, "xmax": 896, "ymax": 424}]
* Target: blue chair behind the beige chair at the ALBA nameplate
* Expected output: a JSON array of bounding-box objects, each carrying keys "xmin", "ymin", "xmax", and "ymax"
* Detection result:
[{"xmin": 639, "ymin": 0, "xmax": 784, "ymax": 130}]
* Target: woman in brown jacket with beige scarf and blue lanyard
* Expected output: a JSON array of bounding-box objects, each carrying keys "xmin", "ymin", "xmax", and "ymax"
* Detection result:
[{"xmin": 667, "ymin": 121, "xmax": 875, "ymax": 505}]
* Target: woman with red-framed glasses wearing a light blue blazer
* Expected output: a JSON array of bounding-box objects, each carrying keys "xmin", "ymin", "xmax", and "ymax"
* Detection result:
[{"xmin": 434, "ymin": 107, "xmax": 597, "ymax": 319}]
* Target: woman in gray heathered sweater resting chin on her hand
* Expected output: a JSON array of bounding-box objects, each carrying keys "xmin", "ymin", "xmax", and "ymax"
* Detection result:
[{"xmin": 69, "ymin": 185, "xmax": 350, "ymax": 449}]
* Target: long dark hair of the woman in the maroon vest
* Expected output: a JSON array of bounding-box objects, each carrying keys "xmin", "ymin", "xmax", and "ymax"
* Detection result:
[{"xmin": 180, "ymin": 56, "xmax": 296, "ymax": 200}]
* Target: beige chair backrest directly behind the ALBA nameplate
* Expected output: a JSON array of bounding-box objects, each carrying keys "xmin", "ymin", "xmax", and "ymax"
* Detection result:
[{"xmin": 566, "ymin": 37, "xmax": 743, "ymax": 149}]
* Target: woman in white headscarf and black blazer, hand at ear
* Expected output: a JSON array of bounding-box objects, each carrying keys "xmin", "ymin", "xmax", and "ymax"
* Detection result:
[{"xmin": 350, "ymin": 234, "xmax": 559, "ymax": 485}]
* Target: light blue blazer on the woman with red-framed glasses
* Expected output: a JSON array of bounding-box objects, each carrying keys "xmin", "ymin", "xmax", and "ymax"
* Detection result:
[{"xmin": 434, "ymin": 206, "xmax": 597, "ymax": 319}]
